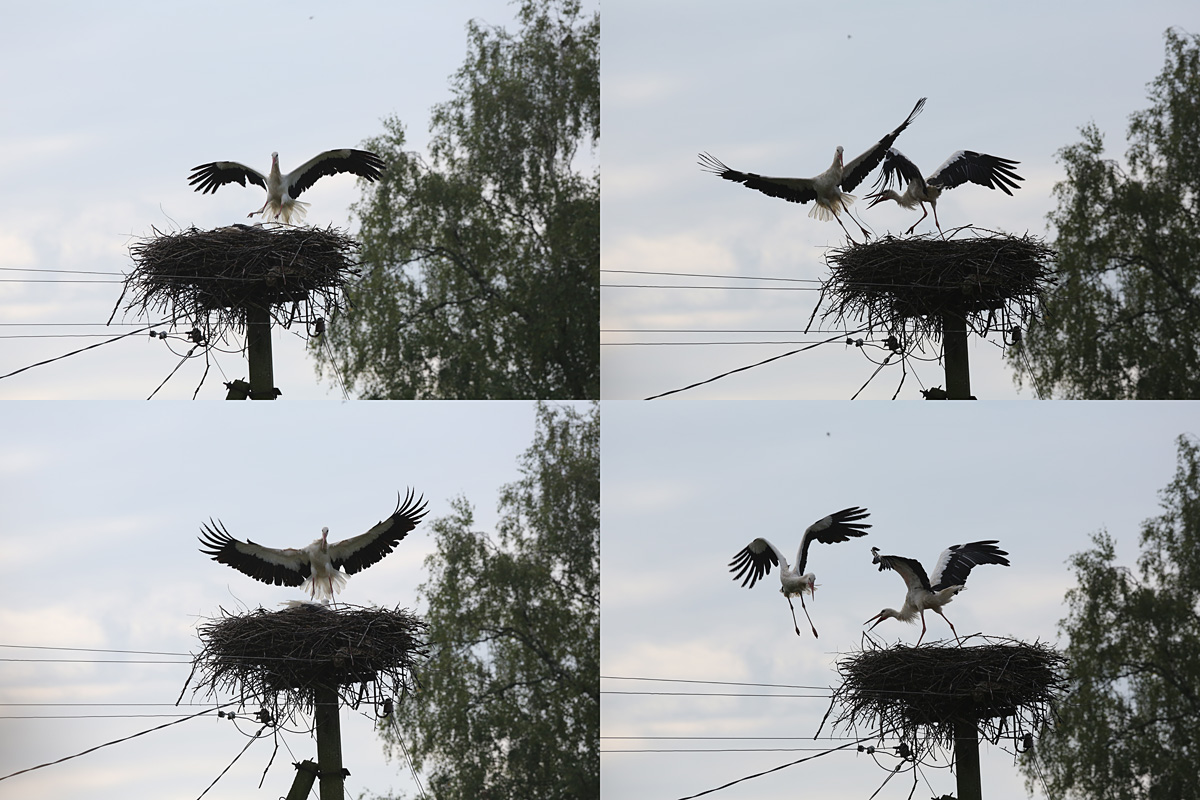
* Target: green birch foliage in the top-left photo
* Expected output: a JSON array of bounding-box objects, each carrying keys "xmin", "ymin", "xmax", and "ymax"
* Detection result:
[{"xmin": 313, "ymin": 0, "xmax": 600, "ymax": 399}]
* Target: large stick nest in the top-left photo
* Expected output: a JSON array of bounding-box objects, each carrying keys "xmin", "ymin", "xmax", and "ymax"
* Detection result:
[{"xmin": 114, "ymin": 225, "xmax": 359, "ymax": 342}]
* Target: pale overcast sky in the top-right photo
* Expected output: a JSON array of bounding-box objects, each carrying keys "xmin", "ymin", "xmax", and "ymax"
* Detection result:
[{"xmin": 601, "ymin": 0, "xmax": 1200, "ymax": 399}]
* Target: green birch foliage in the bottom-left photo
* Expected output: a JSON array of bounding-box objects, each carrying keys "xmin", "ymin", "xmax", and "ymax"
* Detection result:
[{"xmin": 385, "ymin": 405, "xmax": 600, "ymax": 800}]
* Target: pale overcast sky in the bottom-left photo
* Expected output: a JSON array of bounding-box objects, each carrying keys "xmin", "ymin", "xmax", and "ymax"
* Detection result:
[{"xmin": 0, "ymin": 402, "xmax": 583, "ymax": 800}]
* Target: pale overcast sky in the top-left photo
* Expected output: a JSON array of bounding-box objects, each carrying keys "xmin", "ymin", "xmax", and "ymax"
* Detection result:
[{"xmin": 0, "ymin": 0, "xmax": 525, "ymax": 399}]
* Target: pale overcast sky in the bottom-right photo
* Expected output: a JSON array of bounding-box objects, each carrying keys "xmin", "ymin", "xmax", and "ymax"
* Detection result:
[{"xmin": 600, "ymin": 402, "xmax": 1200, "ymax": 800}]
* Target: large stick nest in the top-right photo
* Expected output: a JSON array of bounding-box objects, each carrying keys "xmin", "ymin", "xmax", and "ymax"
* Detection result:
[{"xmin": 822, "ymin": 228, "xmax": 1057, "ymax": 349}]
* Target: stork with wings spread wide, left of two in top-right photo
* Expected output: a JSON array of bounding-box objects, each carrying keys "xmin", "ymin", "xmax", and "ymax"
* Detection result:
[{"xmin": 700, "ymin": 97, "xmax": 925, "ymax": 239}]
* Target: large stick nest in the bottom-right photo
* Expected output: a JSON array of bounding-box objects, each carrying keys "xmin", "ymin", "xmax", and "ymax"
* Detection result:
[{"xmin": 834, "ymin": 637, "xmax": 1067, "ymax": 746}]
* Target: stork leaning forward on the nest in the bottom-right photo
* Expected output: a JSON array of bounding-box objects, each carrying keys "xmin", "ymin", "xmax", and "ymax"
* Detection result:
[{"xmin": 863, "ymin": 539, "xmax": 1008, "ymax": 644}]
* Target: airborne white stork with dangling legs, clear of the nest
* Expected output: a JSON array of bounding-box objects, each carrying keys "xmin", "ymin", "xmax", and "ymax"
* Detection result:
[{"xmin": 730, "ymin": 507, "xmax": 871, "ymax": 637}]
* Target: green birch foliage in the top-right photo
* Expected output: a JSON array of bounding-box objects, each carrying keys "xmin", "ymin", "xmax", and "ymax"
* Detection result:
[{"xmin": 1009, "ymin": 29, "xmax": 1200, "ymax": 399}]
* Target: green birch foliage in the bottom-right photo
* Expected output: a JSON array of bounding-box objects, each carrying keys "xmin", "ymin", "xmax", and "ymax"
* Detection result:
[{"xmin": 1022, "ymin": 437, "xmax": 1200, "ymax": 800}]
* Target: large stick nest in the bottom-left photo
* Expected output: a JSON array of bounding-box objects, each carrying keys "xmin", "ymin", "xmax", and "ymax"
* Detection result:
[{"xmin": 185, "ymin": 603, "xmax": 427, "ymax": 720}]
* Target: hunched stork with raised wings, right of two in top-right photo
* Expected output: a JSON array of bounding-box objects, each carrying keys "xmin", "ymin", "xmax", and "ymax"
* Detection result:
[{"xmin": 866, "ymin": 148, "xmax": 1025, "ymax": 239}]
